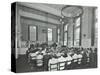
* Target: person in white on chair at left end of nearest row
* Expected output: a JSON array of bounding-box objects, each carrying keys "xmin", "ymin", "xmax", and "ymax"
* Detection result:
[{"xmin": 48, "ymin": 56, "xmax": 58, "ymax": 71}]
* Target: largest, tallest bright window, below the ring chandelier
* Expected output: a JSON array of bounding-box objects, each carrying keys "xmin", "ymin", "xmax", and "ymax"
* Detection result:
[{"xmin": 74, "ymin": 17, "xmax": 80, "ymax": 46}]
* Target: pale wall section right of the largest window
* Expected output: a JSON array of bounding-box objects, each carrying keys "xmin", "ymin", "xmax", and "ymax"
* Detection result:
[{"xmin": 81, "ymin": 7, "xmax": 95, "ymax": 47}]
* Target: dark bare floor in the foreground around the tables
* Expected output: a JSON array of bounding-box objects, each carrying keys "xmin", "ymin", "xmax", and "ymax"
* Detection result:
[{"xmin": 16, "ymin": 55, "xmax": 96, "ymax": 73}]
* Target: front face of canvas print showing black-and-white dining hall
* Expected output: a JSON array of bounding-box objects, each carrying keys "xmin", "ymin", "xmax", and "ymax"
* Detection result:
[{"xmin": 11, "ymin": 2, "xmax": 98, "ymax": 72}]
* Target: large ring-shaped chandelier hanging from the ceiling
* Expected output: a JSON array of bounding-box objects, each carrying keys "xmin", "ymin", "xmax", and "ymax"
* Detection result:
[{"xmin": 61, "ymin": 5, "xmax": 83, "ymax": 18}]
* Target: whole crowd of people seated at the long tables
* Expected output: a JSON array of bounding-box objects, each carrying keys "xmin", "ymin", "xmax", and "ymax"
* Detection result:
[{"xmin": 26, "ymin": 43, "xmax": 97, "ymax": 71}]
